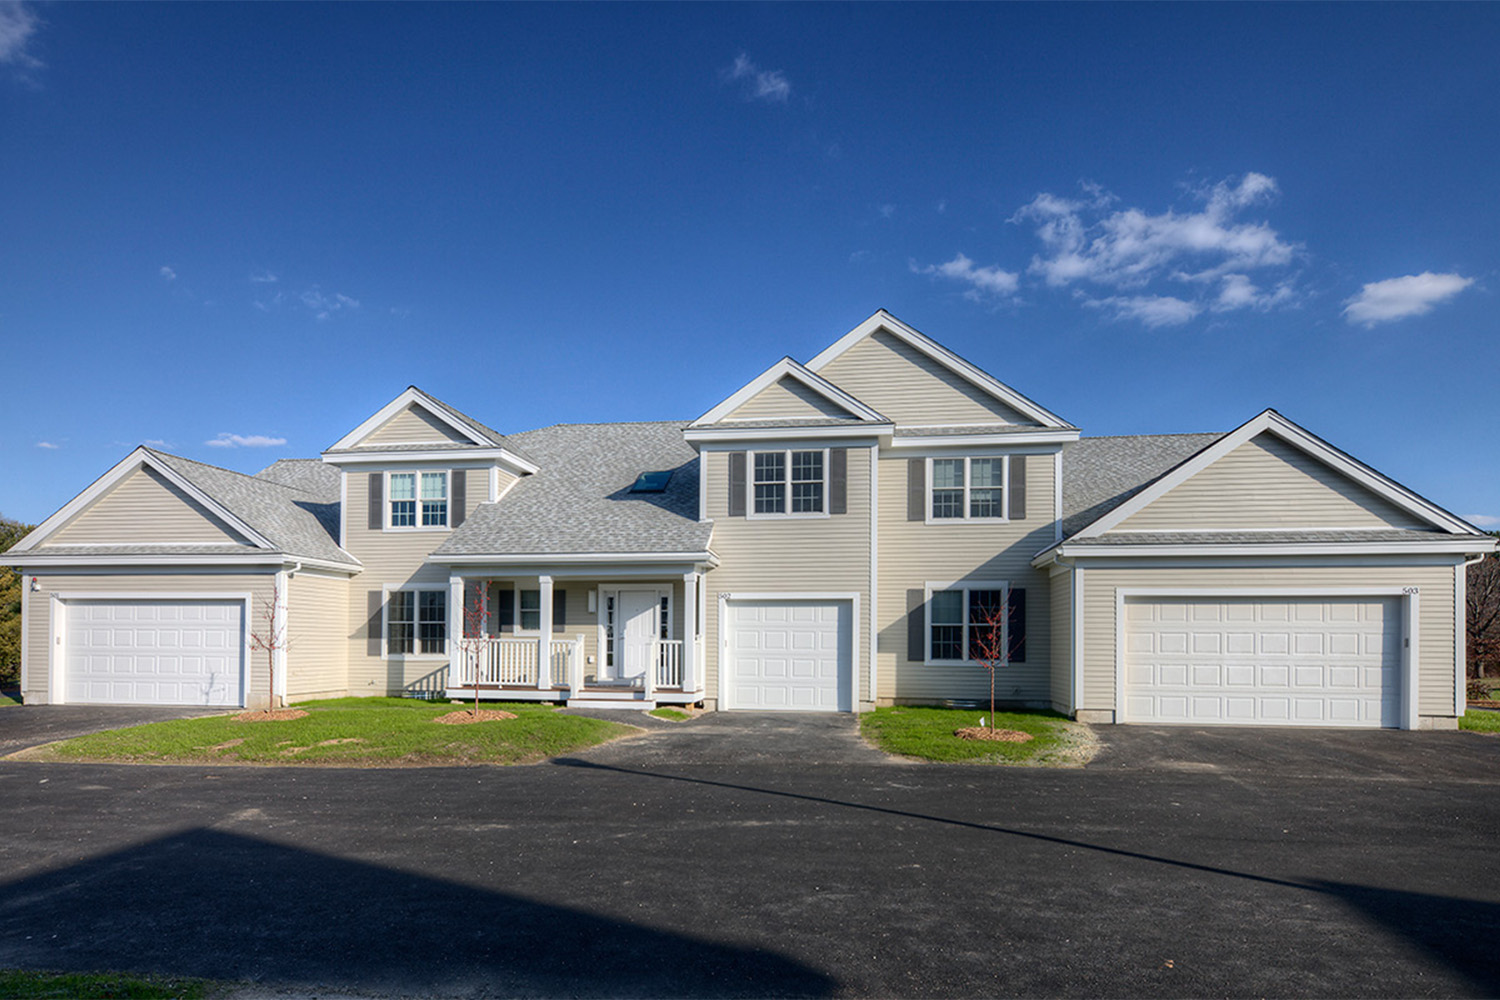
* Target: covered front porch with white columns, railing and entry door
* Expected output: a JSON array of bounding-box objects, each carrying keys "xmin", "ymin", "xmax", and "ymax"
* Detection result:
[{"xmin": 446, "ymin": 571, "xmax": 704, "ymax": 709}]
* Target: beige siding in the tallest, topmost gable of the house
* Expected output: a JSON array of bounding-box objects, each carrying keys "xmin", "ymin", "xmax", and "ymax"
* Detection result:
[{"xmin": 818, "ymin": 330, "xmax": 1035, "ymax": 426}]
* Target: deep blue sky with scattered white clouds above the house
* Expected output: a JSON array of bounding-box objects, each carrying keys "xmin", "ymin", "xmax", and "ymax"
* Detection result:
[{"xmin": 0, "ymin": 0, "xmax": 1500, "ymax": 525}]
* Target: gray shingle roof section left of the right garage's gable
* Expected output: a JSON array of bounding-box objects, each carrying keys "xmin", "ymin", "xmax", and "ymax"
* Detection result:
[{"xmin": 1062, "ymin": 433, "xmax": 1224, "ymax": 538}]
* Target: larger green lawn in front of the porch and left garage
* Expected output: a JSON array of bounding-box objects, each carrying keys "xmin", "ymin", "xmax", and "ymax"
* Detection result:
[{"xmin": 26, "ymin": 699, "xmax": 632, "ymax": 766}]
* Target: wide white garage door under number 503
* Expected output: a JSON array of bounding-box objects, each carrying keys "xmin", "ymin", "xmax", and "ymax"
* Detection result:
[{"xmin": 1122, "ymin": 597, "xmax": 1401, "ymax": 727}]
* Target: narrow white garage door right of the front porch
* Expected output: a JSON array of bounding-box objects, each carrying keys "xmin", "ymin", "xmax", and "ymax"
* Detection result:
[{"xmin": 720, "ymin": 600, "xmax": 854, "ymax": 712}]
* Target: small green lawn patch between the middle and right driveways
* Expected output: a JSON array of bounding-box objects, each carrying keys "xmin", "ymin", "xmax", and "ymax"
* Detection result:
[{"xmin": 860, "ymin": 706, "xmax": 1097, "ymax": 768}]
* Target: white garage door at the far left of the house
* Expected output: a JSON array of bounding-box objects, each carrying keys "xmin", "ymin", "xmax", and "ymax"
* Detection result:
[{"xmin": 63, "ymin": 600, "xmax": 245, "ymax": 706}]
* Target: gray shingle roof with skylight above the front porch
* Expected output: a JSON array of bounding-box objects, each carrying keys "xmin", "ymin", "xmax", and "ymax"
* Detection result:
[{"xmin": 434, "ymin": 421, "xmax": 713, "ymax": 558}]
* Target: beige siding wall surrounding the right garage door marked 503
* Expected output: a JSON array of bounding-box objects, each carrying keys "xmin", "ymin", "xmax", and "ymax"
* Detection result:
[{"xmin": 1080, "ymin": 559, "xmax": 1455, "ymax": 717}]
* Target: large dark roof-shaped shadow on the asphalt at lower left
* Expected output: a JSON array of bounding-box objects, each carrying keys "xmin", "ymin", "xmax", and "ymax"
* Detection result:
[{"xmin": 0, "ymin": 829, "xmax": 839, "ymax": 997}]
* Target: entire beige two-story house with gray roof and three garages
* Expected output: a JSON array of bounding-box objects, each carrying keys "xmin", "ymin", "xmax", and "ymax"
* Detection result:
[{"xmin": 9, "ymin": 310, "xmax": 1494, "ymax": 729}]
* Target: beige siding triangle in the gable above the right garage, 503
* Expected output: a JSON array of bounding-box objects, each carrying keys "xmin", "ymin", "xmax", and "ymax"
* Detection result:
[{"xmin": 1116, "ymin": 433, "xmax": 1430, "ymax": 531}]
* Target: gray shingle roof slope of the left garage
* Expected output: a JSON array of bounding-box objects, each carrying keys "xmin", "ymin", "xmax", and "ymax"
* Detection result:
[{"xmin": 147, "ymin": 448, "xmax": 360, "ymax": 567}]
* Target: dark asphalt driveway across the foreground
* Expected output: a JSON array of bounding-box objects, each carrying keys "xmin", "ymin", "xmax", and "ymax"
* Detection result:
[{"xmin": 0, "ymin": 709, "xmax": 1500, "ymax": 997}]
